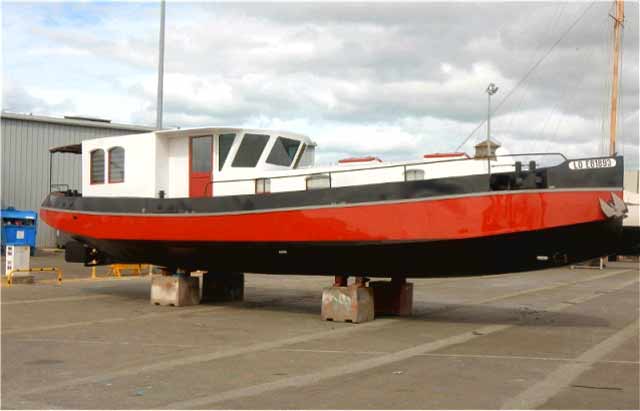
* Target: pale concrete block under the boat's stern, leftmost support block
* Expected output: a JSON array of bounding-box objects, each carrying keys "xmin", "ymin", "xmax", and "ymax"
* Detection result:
[{"xmin": 151, "ymin": 275, "xmax": 200, "ymax": 307}]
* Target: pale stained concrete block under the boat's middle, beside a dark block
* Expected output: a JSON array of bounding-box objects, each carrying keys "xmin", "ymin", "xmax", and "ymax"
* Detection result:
[{"xmin": 321, "ymin": 285, "xmax": 375, "ymax": 323}]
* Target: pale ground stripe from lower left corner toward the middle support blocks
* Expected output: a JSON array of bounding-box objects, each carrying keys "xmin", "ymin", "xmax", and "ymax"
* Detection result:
[{"xmin": 5, "ymin": 270, "xmax": 637, "ymax": 395}]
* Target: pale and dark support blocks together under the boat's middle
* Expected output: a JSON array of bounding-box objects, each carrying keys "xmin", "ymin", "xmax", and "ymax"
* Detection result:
[{"xmin": 321, "ymin": 275, "xmax": 413, "ymax": 323}]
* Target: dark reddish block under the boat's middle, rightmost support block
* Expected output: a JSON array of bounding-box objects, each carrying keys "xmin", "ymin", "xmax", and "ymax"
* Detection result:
[{"xmin": 369, "ymin": 280, "xmax": 413, "ymax": 316}]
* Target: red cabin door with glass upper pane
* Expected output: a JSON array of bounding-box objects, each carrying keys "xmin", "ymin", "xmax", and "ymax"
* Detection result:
[{"xmin": 189, "ymin": 136, "xmax": 213, "ymax": 197}]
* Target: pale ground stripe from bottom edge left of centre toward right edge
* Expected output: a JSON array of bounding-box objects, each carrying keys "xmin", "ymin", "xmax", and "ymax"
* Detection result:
[{"xmin": 158, "ymin": 278, "xmax": 638, "ymax": 409}]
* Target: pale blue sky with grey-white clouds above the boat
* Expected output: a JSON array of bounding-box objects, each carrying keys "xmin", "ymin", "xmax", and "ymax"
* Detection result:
[{"xmin": 2, "ymin": 1, "xmax": 638, "ymax": 168}]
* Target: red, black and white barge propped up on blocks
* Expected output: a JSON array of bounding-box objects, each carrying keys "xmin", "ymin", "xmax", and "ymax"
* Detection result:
[{"xmin": 40, "ymin": 127, "xmax": 625, "ymax": 277}]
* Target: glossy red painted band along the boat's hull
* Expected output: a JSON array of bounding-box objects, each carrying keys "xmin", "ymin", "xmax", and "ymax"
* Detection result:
[{"xmin": 40, "ymin": 190, "xmax": 622, "ymax": 242}]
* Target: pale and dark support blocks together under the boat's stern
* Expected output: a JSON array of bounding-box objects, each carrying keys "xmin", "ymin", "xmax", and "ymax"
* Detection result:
[{"xmin": 151, "ymin": 269, "xmax": 244, "ymax": 307}]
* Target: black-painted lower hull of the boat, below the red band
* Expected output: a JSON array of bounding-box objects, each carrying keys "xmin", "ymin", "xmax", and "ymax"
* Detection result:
[{"xmin": 78, "ymin": 219, "xmax": 622, "ymax": 278}]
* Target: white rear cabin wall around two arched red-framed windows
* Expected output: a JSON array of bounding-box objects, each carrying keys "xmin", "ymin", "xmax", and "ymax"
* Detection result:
[{"xmin": 82, "ymin": 133, "xmax": 156, "ymax": 197}]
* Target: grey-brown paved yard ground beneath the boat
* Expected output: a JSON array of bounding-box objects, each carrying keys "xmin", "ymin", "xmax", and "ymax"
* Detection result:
[{"xmin": 1, "ymin": 256, "xmax": 640, "ymax": 409}]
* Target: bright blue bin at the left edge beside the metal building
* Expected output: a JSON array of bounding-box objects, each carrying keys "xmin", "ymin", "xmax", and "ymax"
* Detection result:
[{"xmin": 0, "ymin": 207, "xmax": 38, "ymax": 255}]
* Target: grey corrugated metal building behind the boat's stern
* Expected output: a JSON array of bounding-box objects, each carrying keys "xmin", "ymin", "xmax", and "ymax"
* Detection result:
[{"xmin": 1, "ymin": 112, "xmax": 154, "ymax": 247}]
